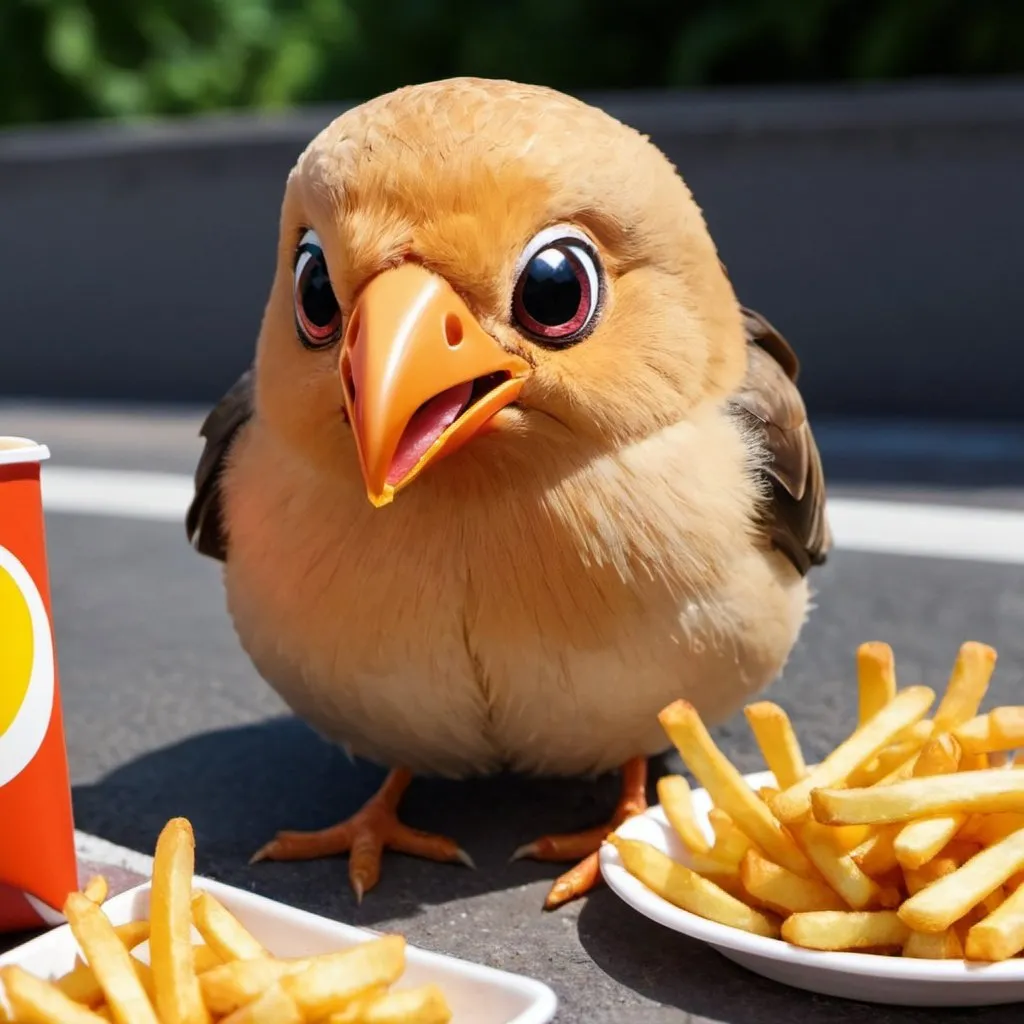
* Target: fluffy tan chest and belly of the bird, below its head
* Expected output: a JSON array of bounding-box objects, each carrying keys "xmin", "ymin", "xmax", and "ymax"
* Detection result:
[{"xmin": 223, "ymin": 399, "xmax": 806, "ymax": 775}]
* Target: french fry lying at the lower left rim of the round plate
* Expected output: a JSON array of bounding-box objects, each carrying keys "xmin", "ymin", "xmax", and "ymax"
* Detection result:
[{"xmin": 607, "ymin": 833, "xmax": 778, "ymax": 938}]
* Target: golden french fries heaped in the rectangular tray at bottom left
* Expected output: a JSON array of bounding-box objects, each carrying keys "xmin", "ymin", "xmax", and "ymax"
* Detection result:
[{"xmin": 0, "ymin": 818, "xmax": 452, "ymax": 1024}]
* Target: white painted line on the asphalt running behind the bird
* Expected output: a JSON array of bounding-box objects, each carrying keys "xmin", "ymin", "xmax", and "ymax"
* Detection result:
[{"xmin": 43, "ymin": 466, "xmax": 1024, "ymax": 565}]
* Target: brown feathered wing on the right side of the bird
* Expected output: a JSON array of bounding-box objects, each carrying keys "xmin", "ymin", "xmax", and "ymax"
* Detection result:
[{"xmin": 732, "ymin": 307, "xmax": 833, "ymax": 575}]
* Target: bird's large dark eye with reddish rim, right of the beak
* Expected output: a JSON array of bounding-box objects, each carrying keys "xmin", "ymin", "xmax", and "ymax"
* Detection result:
[{"xmin": 512, "ymin": 236, "xmax": 601, "ymax": 345}]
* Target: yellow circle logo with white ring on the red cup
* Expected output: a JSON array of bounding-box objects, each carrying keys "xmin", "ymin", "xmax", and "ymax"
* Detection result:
[{"xmin": 0, "ymin": 547, "xmax": 53, "ymax": 785}]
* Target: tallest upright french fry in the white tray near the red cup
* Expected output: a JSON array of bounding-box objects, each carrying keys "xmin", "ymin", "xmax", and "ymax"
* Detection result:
[{"xmin": 150, "ymin": 818, "xmax": 211, "ymax": 1024}]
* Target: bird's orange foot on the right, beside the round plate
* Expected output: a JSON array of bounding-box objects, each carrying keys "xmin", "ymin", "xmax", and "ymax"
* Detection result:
[{"xmin": 512, "ymin": 758, "xmax": 647, "ymax": 910}]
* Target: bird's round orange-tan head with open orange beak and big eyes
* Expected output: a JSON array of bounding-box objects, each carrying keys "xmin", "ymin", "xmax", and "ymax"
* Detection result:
[{"xmin": 251, "ymin": 79, "xmax": 745, "ymax": 506}]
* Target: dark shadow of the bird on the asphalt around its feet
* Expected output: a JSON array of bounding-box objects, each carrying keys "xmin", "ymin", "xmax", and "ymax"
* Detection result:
[{"xmin": 74, "ymin": 718, "xmax": 671, "ymax": 926}]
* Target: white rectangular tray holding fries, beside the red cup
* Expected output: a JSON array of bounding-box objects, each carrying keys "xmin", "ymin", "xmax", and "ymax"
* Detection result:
[{"xmin": 0, "ymin": 877, "xmax": 557, "ymax": 1024}]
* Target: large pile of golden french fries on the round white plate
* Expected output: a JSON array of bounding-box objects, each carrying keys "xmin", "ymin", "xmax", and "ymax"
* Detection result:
[{"xmin": 608, "ymin": 642, "xmax": 1024, "ymax": 962}]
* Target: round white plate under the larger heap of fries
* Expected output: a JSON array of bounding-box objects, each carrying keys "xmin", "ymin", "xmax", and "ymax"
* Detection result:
[{"xmin": 601, "ymin": 772, "xmax": 1024, "ymax": 1007}]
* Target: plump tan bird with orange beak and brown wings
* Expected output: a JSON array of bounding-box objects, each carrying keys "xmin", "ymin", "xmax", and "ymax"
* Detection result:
[{"xmin": 185, "ymin": 77, "xmax": 831, "ymax": 909}]
